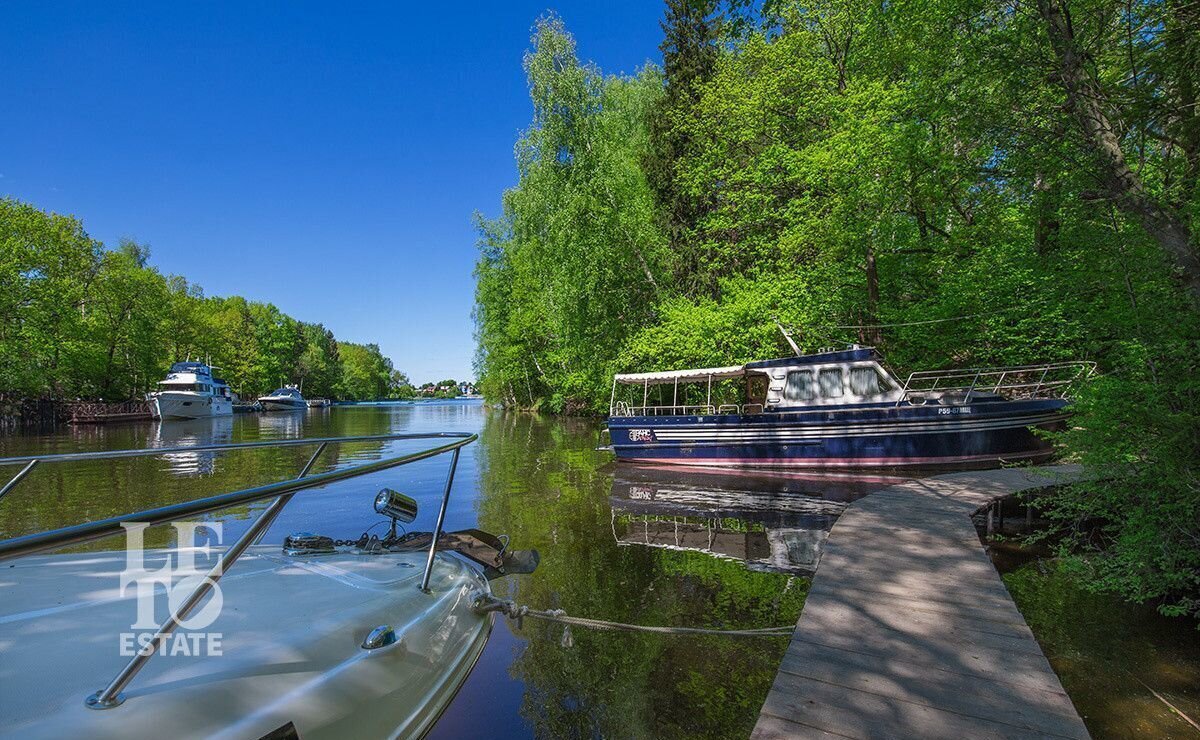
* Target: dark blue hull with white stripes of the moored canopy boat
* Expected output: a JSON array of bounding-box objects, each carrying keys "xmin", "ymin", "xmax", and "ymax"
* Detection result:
[{"xmin": 608, "ymin": 399, "xmax": 1067, "ymax": 468}]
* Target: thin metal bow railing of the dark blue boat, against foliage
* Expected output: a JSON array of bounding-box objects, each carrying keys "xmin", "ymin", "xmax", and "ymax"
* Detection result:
[{"xmin": 896, "ymin": 361, "xmax": 1096, "ymax": 405}]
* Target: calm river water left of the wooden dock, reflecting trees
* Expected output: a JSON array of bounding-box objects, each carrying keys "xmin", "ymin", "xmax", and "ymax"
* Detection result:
[{"xmin": 0, "ymin": 401, "xmax": 887, "ymax": 738}]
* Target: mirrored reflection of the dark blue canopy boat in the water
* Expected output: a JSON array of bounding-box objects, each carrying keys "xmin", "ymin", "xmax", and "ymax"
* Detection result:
[{"xmin": 608, "ymin": 465, "xmax": 905, "ymax": 576}]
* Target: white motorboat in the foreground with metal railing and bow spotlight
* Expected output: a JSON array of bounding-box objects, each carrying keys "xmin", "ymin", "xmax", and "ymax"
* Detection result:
[{"xmin": 0, "ymin": 433, "xmax": 538, "ymax": 740}]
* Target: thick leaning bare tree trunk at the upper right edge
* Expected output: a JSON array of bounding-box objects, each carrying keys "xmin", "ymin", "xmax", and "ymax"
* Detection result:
[{"xmin": 1038, "ymin": 0, "xmax": 1200, "ymax": 301}]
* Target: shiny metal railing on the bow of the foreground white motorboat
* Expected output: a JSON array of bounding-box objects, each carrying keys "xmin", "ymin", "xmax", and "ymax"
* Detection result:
[{"xmin": 0, "ymin": 432, "xmax": 479, "ymax": 709}]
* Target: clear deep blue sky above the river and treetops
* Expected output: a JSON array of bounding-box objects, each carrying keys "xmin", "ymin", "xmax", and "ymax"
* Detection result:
[{"xmin": 0, "ymin": 5, "xmax": 662, "ymax": 381}]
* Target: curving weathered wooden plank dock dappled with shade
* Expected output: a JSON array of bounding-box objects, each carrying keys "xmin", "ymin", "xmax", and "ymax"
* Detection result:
[{"xmin": 752, "ymin": 465, "xmax": 1088, "ymax": 740}]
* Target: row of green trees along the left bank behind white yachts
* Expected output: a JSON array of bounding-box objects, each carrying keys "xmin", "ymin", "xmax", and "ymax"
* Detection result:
[{"xmin": 0, "ymin": 198, "xmax": 418, "ymax": 420}]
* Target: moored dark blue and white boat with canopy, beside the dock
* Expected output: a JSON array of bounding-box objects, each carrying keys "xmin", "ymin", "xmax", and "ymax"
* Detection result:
[{"xmin": 608, "ymin": 345, "xmax": 1094, "ymax": 468}]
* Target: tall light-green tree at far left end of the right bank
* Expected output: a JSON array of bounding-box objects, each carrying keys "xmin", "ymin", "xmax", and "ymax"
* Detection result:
[{"xmin": 475, "ymin": 17, "xmax": 670, "ymax": 410}]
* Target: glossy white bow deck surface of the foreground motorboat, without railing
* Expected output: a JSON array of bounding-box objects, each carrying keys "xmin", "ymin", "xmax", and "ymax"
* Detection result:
[{"xmin": 0, "ymin": 546, "xmax": 493, "ymax": 740}]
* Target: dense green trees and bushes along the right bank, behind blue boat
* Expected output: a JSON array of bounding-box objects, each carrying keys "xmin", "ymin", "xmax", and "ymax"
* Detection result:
[{"xmin": 474, "ymin": 0, "xmax": 1200, "ymax": 618}]
